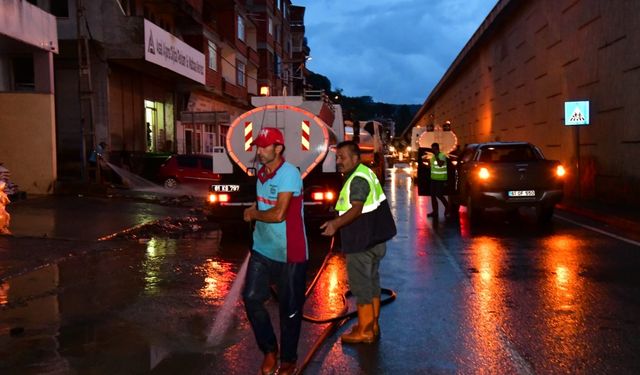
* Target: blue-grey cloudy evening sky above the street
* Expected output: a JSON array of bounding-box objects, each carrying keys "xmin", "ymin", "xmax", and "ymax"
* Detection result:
[{"xmin": 292, "ymin": 0, "xmax": 497, "ymax": 104}]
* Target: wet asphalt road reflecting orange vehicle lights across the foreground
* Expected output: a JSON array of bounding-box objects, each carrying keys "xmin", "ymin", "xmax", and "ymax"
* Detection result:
[{"xmin": 0, "ymin": 174, "xmax": 640, "ymax": 374}]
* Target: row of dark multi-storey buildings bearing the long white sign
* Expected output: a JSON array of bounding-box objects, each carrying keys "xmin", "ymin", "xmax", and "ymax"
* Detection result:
[{"xmin": 0, "ymin": 0, "xmax": 308, "ymax": 188}]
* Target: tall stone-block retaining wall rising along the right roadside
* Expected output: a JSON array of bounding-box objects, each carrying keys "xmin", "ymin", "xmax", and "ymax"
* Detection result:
[{"xmin": 414, "ymin": 0, "xmax": 640, "ymax": 204}]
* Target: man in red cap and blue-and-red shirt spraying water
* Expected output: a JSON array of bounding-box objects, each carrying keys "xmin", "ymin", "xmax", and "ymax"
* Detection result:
[{"xmin": 242, "ymin": 127, "xmax": 309, "ymax": 374}]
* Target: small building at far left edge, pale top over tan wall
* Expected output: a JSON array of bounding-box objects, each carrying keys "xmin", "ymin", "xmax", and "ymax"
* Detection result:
[{"xmin": 0, "ymin": 0, "xmax": 59, "ymax": 194}]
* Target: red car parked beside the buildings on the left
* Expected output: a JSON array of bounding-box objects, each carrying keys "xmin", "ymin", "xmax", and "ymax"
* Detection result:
[{"xmin": 158, "ymin": 155, "xmax": 220, "ymax": 190}]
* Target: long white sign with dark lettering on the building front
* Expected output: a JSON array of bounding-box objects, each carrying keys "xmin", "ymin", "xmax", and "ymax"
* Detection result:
[{"xmin": 144, "ymin": 20, "xmax": 205, "ymax": 85}]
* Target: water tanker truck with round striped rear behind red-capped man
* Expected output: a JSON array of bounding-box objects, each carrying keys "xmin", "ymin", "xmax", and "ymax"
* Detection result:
[{"xmin": 208, "ymin": 96, "xmax": 345, "ymax": 219}]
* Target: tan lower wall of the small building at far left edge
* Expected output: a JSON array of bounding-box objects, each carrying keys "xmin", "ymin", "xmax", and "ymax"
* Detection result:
[{"xmin": 0, "ymin": 93, "xmax": 57, "ymax": 194}]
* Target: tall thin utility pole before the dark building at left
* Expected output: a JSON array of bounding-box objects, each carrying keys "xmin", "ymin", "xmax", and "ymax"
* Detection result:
[{"xmin": 76, "ymin": 0, "xmax": 100, "ymax": 182}]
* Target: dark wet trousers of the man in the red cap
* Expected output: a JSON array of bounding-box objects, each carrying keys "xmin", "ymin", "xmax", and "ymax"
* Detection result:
[{"xmin": 242, "ymin": 251, "xmax": 307, "ymax": 362}]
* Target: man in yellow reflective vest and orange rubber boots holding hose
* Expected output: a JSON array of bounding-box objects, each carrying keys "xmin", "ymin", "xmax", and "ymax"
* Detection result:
[{"xmin": 320, "ymin": 141, "xmax": 396, "ymax": 344}]
